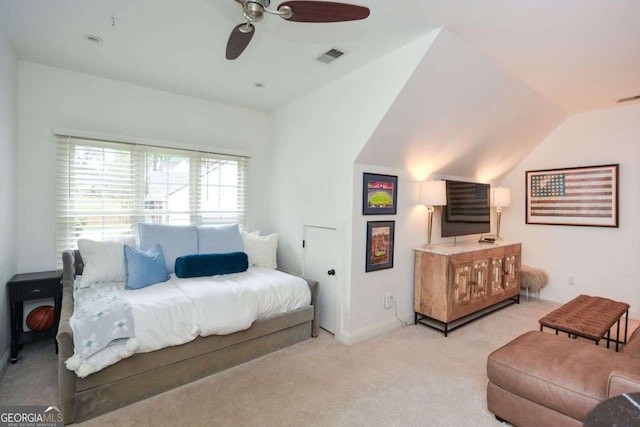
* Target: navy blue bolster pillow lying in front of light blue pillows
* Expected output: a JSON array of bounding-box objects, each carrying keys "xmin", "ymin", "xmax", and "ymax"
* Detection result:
[{"xmin": 175, "ymin": 252, "xmax": 249, "ymax": 279}]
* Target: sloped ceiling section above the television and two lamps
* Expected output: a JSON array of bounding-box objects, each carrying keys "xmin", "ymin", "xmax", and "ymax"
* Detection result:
[{"xmin": 357, "ymin": 29, "xmax": 567, "ymax": 182}]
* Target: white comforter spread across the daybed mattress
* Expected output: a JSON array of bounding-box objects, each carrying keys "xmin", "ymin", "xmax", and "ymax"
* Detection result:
[{"xmin": 67, "ymin": 267, "xmax": 311, "ymax": 378}]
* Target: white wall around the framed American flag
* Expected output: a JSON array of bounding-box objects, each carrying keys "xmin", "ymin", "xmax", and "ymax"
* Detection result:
[{"xmin": 502, "ymin": 103, "xmax": 640, "ymax": 318}]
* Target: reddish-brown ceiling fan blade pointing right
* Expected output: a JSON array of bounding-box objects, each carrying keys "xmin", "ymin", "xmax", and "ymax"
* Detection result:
[{"xmin": 278, "ymin": 0, "xmax": 369, "ymax": 22}]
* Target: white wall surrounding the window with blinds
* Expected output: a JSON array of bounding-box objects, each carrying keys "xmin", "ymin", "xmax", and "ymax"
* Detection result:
[{"xmin": 16, "ymin": 61, "xmax": 269, "ymax": 272}]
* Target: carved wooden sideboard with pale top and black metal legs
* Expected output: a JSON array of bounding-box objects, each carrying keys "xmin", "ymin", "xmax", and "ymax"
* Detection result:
[{"xmin": 414, "ymin": 241, "xmax": 521, "ymax": 337}]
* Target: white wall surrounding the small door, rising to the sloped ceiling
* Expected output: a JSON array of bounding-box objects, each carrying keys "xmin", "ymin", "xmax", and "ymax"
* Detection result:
[{"xmin": 270, "ymin": 32, "xmax": 437, "ymax": 340}]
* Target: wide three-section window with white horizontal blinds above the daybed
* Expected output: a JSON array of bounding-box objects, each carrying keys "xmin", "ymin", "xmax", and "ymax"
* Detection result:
[{"xmin": 56, "ymin": 136, "xmax": 249, "ymax": 252}]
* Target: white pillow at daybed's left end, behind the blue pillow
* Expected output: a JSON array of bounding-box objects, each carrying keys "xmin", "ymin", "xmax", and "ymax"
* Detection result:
[{"xmin": 78, "ymin": 237, "xmax": 136, "ymax": 286}]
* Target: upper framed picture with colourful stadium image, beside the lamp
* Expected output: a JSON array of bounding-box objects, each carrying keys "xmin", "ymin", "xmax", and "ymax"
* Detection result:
[{"xmin": 362, "ymin": 172, "xmax": 398, "ymax": 215}]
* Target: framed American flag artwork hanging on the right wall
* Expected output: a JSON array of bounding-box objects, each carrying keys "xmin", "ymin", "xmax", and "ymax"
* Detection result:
[{"xmin": 526, "ymin": 165, "xmax": 619, "ymax": 227}]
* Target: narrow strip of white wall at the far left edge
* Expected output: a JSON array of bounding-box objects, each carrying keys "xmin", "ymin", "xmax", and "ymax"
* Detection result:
[{"xmin": 0, "ymin": 28, "xmax": 18, "ymax": 378}]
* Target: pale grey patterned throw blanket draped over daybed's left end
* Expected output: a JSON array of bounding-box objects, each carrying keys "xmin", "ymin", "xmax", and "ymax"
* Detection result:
[{"xmin": 65, "ymin": 283, "xmax": 138, "ymax": 378}]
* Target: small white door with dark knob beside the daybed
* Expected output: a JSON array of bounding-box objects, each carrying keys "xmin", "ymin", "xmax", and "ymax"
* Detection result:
[{"xmin": 303, "ymin": 225, "xmax": 340, "ymax": 334}]
